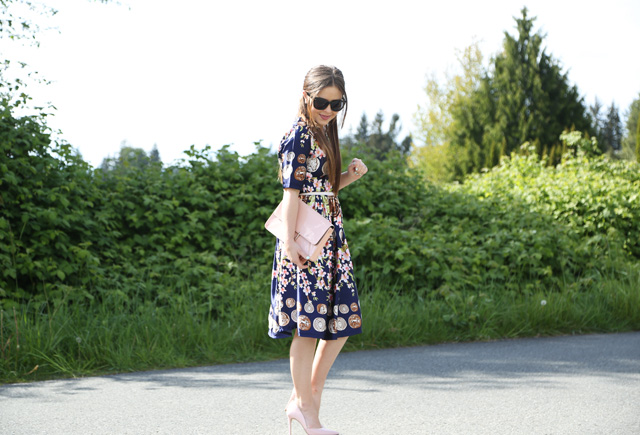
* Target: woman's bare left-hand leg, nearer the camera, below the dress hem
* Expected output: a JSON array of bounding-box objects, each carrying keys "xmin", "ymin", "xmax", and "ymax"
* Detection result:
[{"xmin": 289, "ymin": 334, "xmax": 322, "ymax": 428}]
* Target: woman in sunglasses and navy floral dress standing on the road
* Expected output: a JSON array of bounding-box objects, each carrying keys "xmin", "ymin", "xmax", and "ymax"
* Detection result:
[{"xmin": 269, "ymin": 65, "xmax": 367, "ymax": 435}]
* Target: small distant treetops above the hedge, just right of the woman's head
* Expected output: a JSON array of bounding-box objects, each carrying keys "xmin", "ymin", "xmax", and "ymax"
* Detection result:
[{"xmin": 340, "ymin": 111, "xmax": 412, "ymax": 160}]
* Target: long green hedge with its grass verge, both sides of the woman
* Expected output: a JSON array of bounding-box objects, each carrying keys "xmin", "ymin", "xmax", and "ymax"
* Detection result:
[{"xmin": 0, "ymin": 104, "xmax": 640, "ymax": 379}]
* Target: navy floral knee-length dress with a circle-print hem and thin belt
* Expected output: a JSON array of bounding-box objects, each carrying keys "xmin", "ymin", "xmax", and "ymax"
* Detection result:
[{"xmin": 269, "ymin": 123, "xmax": 362, "ymax": 340}]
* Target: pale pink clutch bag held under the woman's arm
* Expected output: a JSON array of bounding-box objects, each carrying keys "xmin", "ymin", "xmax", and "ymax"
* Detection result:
[{"xmin": 264, "ymin": 199, "xmax": 333, "ymax": 262}]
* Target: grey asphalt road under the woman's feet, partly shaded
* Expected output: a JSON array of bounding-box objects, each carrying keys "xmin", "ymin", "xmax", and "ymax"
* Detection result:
[{"xmin": 0, "ymin": 332, "xmax": 640, "ymax": 435}]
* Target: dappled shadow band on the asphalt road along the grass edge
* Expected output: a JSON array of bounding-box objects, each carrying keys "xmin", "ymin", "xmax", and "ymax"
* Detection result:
[{"xmin": 0, "ymin": 332, "xmax": 640, "ymax": 401}]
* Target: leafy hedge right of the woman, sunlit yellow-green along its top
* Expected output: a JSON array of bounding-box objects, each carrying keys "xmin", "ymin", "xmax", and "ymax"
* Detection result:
[{"xmin": 341, "ymin": 132, "xmax": 640, "ymax": 294}]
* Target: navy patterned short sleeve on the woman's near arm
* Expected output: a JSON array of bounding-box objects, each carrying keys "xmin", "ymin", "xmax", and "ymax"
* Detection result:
[{"xmin": 278, "ymin": 125, "xmax": 311, "ymax": 190}]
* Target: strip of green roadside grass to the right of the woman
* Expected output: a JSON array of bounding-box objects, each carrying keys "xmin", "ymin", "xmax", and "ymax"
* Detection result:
[{"xmin": 347, "ymin": 268, "xmax": 640, "ymax": 349}]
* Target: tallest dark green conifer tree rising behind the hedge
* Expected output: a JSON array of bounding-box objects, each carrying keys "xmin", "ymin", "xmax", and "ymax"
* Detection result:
[{"xmin": 449, "ymin": 8, "xmax": 593, "ymax": 174}]
